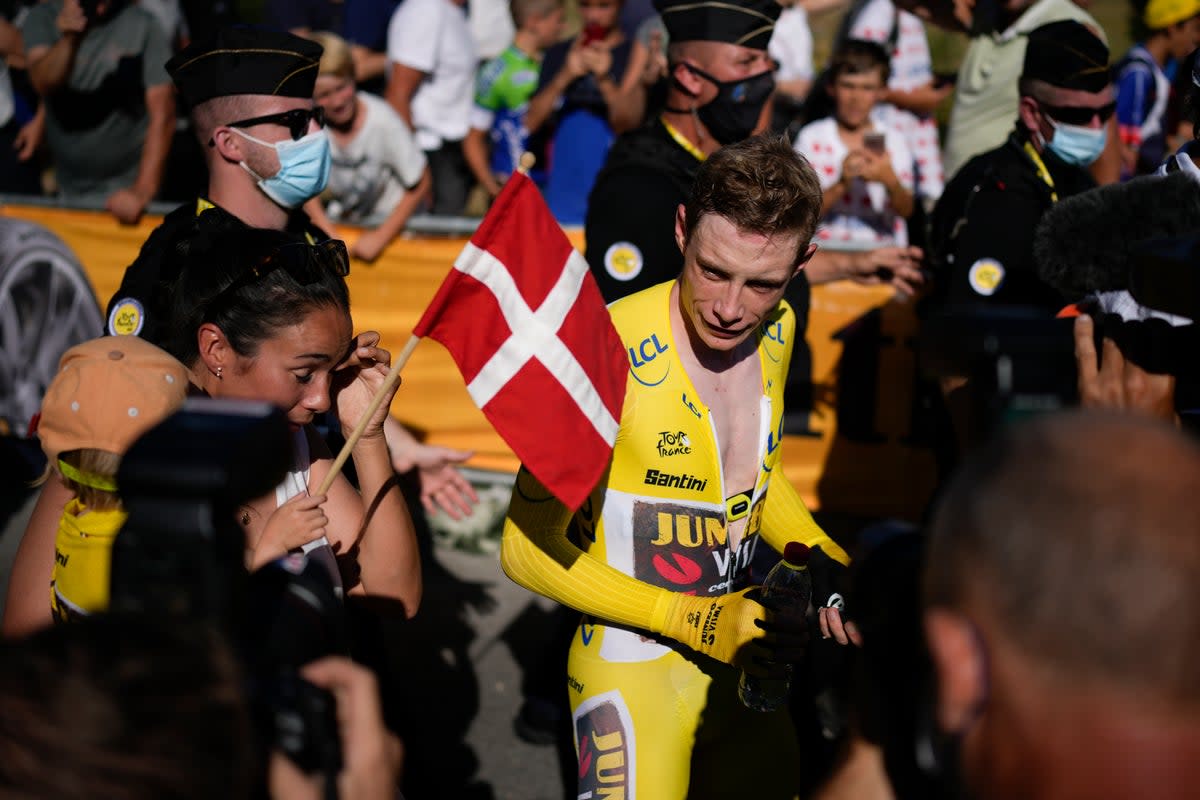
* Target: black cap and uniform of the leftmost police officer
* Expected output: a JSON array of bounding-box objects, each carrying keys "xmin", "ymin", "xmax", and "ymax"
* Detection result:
[{"xmin": 107, "ymin": 28, "xmax": 328, "ymax": 344}]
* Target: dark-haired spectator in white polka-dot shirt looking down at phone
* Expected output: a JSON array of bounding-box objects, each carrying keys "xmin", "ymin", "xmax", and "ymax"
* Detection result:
[{"xmin": 796, "ymin": 40, "xmax": 913, "ymax": 248}]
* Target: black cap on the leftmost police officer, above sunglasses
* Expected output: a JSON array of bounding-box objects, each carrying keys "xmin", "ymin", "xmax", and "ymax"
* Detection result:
[{"xmin": 167, "ymin": 26, "xmax": 324, "ymax": 107}]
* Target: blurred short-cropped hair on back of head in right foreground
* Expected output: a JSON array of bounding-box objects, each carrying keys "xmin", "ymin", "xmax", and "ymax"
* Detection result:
[{"xmin": 924, "ymin": 411, "xmax": 1200, "ymax": 709}]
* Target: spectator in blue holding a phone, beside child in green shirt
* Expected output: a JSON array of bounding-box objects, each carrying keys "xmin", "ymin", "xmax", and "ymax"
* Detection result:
[{"xmin": 526, "ymin": 0, "xmax": 648, "ymax": 225}]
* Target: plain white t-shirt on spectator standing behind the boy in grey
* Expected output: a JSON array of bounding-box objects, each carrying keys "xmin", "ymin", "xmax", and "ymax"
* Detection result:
[{"xmin": 388, "ymin": 0, "xmax": 478, "ymax": 150}]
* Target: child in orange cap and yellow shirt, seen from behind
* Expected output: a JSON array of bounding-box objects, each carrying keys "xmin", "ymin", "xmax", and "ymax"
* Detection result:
[{"xmin": 37, "ymin": 336, "xmax": 188, "ymax": 622}]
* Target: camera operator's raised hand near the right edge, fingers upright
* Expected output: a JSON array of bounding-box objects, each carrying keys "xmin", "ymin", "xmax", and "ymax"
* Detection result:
[{"xmin": 1075, "ymin": 314, "xmax": 1178, "ymax": 423}]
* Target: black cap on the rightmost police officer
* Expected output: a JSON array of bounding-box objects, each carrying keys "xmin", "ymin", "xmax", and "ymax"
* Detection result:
[{"xmin": 1021, "ymin": 19, "xmax": 1110, "ymax": 92}]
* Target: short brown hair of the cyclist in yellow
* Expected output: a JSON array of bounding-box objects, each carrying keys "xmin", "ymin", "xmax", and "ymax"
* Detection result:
[{"xmin": 684, "ymin": 134, "xmax": 821, "ymax": 255}]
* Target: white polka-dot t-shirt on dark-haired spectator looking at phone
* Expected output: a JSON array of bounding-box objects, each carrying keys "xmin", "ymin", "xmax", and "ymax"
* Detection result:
[{"xmin": 796, "ymin": 116, "xmax": 912, "ymax": 248}]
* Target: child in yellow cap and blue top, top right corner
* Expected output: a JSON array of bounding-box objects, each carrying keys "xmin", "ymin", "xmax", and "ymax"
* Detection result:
[{"xmin": 1114, "ymin": 0, "xmax": 1200, "ymax": 178}]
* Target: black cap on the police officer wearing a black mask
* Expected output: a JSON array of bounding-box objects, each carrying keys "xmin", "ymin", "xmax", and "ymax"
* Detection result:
[{"xmin": 654, "ymin": 0, "xmax": 782, "ymax": 50}]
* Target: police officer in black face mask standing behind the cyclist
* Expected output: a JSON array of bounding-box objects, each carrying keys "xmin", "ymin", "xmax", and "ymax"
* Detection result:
[{"xmin": 584, "ymin": 0, "xmax": 781, "ymax": 301}]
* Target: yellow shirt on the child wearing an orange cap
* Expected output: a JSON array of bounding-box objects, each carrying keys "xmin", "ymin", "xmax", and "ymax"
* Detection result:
[{"xmin": 50, "ymin": 499, "xmax": 126, "ymax": 622}]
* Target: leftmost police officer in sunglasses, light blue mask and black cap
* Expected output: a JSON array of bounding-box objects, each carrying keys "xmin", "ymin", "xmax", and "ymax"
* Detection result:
[{"xmin": 108, "ymin": 28, "xmax": 330, "ymax": 344}]
